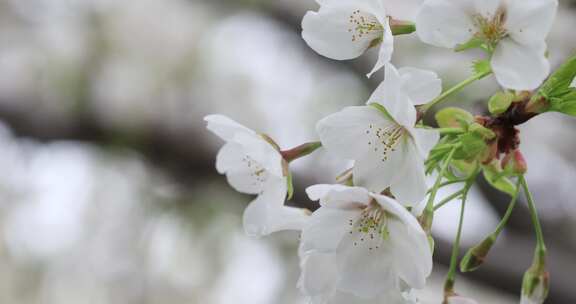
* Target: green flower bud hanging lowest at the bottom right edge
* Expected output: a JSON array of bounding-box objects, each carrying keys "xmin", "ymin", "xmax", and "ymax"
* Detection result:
[{"xmin": 520, "ymin": 267, "xmax": 550, "ymax": 304}]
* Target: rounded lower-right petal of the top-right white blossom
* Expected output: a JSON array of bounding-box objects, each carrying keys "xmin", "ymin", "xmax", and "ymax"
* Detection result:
[{"xmin": 492, "ymin": 39, "xmax": 550, "ymax": 90}]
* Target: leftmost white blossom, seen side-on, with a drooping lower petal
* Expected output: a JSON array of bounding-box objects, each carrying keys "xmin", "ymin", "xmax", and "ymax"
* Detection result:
[{"xmin": 204, "ymin": 115, "xmax": 307, "ymax": 236}]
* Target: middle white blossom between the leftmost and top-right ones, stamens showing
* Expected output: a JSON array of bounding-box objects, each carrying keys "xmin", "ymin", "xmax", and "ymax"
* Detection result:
[{"xmin": 316, "ymin": 64, "xmax": 441, "ymax": 205}]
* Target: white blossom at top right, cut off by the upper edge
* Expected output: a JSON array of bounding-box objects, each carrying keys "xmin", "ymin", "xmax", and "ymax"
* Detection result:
[{"xmin": 416, "ymin": 0, "xmax": 558, "ymax": 90}]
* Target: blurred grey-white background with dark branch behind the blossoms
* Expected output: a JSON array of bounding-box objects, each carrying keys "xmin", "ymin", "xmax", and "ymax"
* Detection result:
[{"xmin": 0, "ymin": 0, "xmax": 576, "ymax": 304}]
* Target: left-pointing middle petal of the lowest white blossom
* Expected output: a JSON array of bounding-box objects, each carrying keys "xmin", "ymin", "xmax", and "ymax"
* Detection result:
[{"xmin": 301, "ymin": 207, "xmax": 361, "ymax": 252}]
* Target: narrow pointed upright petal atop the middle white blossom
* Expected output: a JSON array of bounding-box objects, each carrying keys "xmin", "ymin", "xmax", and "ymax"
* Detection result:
[{"xmin": 366, "ymin": 64, "xmax": 416, "ymax": 127}]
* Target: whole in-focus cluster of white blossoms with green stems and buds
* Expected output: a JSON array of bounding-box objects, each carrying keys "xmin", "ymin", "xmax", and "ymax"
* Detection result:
[{"xmin": 205, "ymin": 0, "xmax": 576, "ymax": 304}]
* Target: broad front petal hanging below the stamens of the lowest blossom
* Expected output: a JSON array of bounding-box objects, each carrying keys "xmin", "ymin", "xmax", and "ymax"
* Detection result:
[{"xmin": 337, "ymin": 227, "xmax": 397, "ymax": 298}]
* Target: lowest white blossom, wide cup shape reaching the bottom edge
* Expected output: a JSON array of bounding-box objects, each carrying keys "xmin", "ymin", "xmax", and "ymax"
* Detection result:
[{"xmin": 300, "ymin": 185, "xmax": 432, "ymax": 303}]
